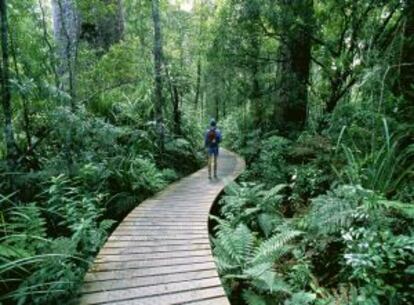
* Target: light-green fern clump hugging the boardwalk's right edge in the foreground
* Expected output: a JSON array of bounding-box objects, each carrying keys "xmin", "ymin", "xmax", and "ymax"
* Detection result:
[{"xmin": 213, "ymin": 184, "xmax": 308, "ymax": 304}]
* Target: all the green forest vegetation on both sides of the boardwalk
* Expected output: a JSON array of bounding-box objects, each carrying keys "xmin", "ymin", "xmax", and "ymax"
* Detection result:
[{"xmin": 0, "ymin": 0, "xmax": 414, "ymax": 305}]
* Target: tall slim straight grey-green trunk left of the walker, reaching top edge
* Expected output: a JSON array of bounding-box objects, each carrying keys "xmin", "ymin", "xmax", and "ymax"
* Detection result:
[{"xmin": 151, "ymin": 0, "xmax": 164, "ymax": 153}]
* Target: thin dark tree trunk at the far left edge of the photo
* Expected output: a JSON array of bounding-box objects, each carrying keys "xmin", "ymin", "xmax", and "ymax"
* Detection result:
[{"xmin": 0, "ymin": 0, "xmax": 18, "ymax": 183}]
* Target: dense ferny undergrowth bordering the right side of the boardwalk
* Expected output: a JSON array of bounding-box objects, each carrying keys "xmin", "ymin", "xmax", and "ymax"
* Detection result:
[{"xmin": 212, "ymin": 113, "xmax": 414, "ymax": 305}]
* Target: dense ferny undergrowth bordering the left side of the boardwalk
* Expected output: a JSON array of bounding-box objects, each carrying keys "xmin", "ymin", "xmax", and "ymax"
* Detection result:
[{"xmin": 0, "ymin": 109, "xmax": 202, "ymax": 305}]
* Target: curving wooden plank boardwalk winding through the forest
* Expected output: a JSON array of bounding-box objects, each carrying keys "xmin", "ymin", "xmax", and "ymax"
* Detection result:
[{"xmin": 80, "ymin": 150, "xmax": 244, "ymax": 305}]
